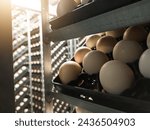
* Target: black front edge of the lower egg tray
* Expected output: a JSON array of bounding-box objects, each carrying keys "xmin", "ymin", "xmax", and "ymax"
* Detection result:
[{"xmin": 52, "ymin": 76, "xmax": 150, "ymax": 113}]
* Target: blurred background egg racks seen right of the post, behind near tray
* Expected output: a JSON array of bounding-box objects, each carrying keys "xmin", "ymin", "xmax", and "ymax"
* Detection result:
[{"xmin": 51, "ymin": 38, "xmax": 83, "ymax": 113}]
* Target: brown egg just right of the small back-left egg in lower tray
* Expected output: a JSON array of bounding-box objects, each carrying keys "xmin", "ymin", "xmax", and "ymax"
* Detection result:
[{"xmin": 96, "ymin": 36, "xmax": 117, "ymax": 53}]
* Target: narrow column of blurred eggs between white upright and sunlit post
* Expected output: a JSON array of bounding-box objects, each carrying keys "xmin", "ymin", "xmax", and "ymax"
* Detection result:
[{"xmin": 29, "ymin": 12, "xmax": 45, "ymax": 112}]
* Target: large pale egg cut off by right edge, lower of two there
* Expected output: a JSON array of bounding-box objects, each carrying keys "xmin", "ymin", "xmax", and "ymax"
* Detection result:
[{"xmin": 139, "ymin": 49, "xmax": 150, "ymax": 78}]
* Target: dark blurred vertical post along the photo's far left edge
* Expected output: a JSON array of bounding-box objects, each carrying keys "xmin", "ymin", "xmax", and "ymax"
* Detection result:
[{"xmin": 0, "ymin": 0, "xmax": 15, "ymax": 112}]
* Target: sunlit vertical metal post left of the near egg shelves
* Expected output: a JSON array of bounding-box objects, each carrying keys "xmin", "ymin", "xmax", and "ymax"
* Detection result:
[{"xmin": 41, "ymin": 0, "xmax": 52, "ymax": 98}]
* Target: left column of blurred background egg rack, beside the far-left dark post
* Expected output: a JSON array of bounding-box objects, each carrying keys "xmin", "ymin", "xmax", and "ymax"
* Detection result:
[{"xmin": 12, "ymin": 7, "xmax": 31, "ymax": 112}]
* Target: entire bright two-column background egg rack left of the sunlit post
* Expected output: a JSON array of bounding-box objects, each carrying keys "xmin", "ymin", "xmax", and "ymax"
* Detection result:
[{"xmin": 12, "ymin": 6, "xmax": 45, "ymax": 112}]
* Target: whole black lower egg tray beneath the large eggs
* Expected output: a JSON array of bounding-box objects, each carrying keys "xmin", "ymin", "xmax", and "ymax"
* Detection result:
[{"xmin": 53, "ymin": 69, "xmax": 150, "ymax": 112}]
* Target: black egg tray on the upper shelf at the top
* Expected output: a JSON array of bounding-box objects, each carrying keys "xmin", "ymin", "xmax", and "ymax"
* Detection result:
[{"xmin": 50, "ymin": 0, "xmax": 140, "ymax": 30}]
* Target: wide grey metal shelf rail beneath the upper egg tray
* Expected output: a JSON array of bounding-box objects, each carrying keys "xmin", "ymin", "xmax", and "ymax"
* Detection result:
[{"xmin": 47, "ymin": 0, "xmax": 150, "ymax": 41}]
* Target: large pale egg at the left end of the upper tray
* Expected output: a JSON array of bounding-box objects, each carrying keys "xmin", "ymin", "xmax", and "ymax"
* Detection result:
[{"xmin": 57, "ymin": 0, "xmax": 77, "ymax": 17}]
